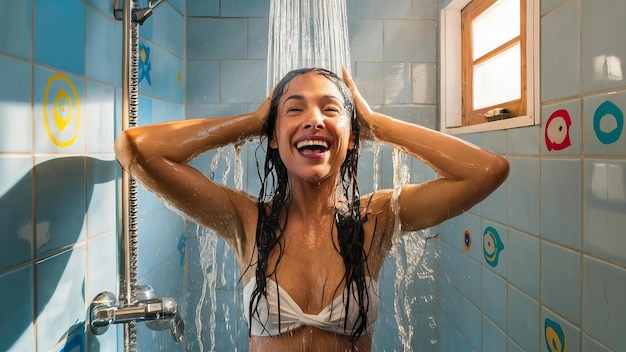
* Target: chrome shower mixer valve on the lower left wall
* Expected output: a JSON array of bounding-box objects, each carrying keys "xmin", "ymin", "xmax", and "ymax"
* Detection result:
[{"xmin": 89, "ymin": 286, "xmax": 185, "ymax": 342}]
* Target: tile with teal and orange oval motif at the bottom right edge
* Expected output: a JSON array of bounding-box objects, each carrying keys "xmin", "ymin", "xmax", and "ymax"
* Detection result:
[{"xmin": 540, "ymin": 307, "xmax": 580, "ymax": 352}]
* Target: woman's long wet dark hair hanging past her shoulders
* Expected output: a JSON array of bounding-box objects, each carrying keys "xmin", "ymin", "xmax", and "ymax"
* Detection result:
[{"xmin": 248, "ymin": 68, "xmax": 371, "ymax": 343}]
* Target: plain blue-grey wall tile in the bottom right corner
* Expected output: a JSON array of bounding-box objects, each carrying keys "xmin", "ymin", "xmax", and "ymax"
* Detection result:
[{"xmin": 582, "ymin": 256, "xmax": 626, "ymax": 350}]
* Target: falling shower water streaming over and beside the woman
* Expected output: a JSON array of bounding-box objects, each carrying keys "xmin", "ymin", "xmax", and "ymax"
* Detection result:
[{"xmin": 190, "ymin": 0, "xmax": 437, "ymax": 351}]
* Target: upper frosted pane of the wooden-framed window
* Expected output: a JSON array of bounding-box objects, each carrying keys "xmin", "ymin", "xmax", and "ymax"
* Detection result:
[{"xmin": 472, "ymin": 0, "xmax": 520, "ymax": 60}]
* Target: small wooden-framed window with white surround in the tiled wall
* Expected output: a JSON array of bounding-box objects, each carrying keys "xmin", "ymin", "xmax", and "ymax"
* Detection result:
[{"xmin": 440, "ymin": 0, "xmax": 540, "ymax": 133}]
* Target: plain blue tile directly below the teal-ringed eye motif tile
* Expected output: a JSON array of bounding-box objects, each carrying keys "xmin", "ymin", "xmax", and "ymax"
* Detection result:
[{"xmin": 482, "ymin": 267, "xmax": 507, "ymax": 330}]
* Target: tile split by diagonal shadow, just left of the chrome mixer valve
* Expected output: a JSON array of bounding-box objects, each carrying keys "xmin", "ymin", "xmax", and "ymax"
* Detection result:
[{"xmin": 35, "ymin": 246, "xmax": 86, "ymax": 351}]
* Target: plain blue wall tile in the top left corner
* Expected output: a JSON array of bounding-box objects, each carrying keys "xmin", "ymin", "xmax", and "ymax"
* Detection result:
[{"xmin": 0, "ymin": 0, "xmax": 32, "ymax": 59}]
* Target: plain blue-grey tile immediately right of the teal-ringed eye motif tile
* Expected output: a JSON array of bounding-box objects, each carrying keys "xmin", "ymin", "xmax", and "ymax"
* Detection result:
[{"xmin": 508, "ymin": 229, "xmax": 541, "ymax": 299}]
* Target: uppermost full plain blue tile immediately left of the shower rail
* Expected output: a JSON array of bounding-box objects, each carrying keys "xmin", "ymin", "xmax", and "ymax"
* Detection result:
[{"xmin": 85, "ymin": 7, "xmax": 122, "ymax": 85}]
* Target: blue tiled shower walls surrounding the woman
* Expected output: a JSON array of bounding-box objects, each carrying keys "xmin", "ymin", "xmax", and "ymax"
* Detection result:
[{"xmin": 0, "ymin": 0, "xmax": 626, "ymax": 351}]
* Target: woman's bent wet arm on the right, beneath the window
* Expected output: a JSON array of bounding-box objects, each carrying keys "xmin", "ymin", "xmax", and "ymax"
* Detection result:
[{"xmin": 344, "ymin": 70, "xmax": 509, "ymax": 231}]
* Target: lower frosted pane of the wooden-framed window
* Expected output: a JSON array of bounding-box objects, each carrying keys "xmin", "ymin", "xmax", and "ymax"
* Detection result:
[{"xmin": 473, "ymin": 43, "xmax": 521, "ymax": 109}]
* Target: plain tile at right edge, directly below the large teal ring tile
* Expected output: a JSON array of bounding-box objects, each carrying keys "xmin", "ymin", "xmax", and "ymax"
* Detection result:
[{"xmin": 584, "ymin": 159, "xmax": 626, "ymax": 265}]
